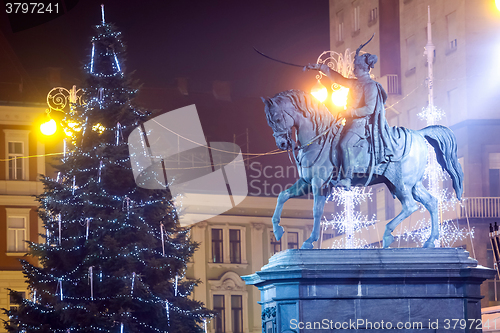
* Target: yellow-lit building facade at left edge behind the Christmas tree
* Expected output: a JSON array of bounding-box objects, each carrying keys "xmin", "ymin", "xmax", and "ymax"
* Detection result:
[{"xmin": 0, "ymin": 103, "xmax": 46, "ymax": 332}]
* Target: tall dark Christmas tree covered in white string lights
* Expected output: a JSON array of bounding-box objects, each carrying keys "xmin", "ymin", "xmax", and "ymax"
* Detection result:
[{"xmin": 5, "ymin": 7, "xmax": 211, "ymax": 333}]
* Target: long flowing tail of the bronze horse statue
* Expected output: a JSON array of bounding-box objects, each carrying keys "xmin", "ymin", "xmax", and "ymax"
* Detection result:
[{"xmin": 418, "ymin": 125, "xmax": 464, "ymax": 200}]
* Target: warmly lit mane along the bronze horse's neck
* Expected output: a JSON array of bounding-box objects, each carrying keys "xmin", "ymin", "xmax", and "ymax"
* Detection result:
[{"xmin": 271, "ymin": 90, "xmax": 337, "ymax": 134}]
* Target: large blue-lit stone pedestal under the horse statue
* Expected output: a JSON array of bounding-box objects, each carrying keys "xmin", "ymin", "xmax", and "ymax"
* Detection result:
[{"xmin": 243, "ymin": 248, "xmax": 495, "ymax": 333}]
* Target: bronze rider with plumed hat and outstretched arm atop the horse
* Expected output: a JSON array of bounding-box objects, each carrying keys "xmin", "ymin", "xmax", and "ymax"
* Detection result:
[{"xmin": 306, "ymin": 36, "xmax": 404, "ymax": 189}]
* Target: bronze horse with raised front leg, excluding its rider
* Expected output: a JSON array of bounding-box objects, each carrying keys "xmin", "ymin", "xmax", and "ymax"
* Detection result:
[{"xmin": 262, "ymin": 90, "xmax": 463, "ymax": 249}]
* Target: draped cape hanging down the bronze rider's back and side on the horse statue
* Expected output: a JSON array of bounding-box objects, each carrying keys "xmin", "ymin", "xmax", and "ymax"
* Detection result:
[{"xmin": 369, "ymin": 82, "xmax": 411, "ymax": 165}]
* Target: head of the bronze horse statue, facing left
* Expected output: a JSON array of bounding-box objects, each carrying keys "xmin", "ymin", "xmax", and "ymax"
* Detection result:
[{"xmin": 261, "ymin": 97, "xmax": 294, "ymax": 150}]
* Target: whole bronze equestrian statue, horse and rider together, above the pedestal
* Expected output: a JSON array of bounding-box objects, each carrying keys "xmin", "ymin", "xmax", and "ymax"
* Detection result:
[{"xmin": 262, "ymin": 37, "xmax": 463, "ymax": 249}]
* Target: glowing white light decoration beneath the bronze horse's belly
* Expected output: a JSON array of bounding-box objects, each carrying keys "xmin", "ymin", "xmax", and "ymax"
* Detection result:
[{"xmin": 322, "ymin": 186, "xmax": 377, "ymax": 249}]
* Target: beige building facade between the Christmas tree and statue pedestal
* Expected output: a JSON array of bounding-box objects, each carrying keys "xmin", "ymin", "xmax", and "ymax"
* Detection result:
[{"xmin": 185, "ymin": 196, "xmax": 334, "ymax": 333}]
